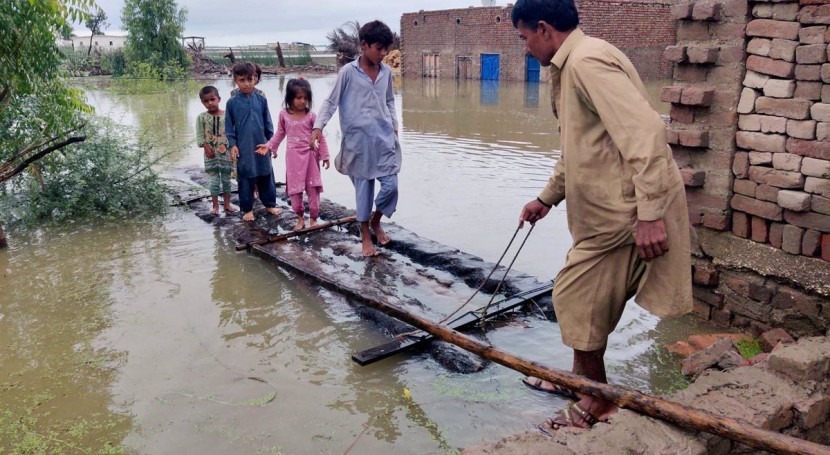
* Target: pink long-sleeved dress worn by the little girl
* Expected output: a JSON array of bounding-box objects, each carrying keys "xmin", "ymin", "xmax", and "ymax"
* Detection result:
[{"xmin": 267, "ymin": 109, "xmax": 329, "ymax": 196}]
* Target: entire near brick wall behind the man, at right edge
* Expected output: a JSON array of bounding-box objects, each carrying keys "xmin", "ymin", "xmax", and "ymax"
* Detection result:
[{"xmin": 661, "ymin": 0, "xmax": 830, "ymax": 336}]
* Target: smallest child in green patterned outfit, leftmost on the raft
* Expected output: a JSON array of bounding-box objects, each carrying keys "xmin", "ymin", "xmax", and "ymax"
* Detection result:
[{"xmin": 196, "ymin": 85, "xmax": 237, "ymax": 215}]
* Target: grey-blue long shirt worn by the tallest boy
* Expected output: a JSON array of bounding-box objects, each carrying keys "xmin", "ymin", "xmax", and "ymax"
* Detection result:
[{"xmin": 314, "ymin": 60, "xmax": 401, "ymax": 179}]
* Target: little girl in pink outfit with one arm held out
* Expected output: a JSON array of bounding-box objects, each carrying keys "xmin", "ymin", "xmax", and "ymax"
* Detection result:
[{"xmin": 257, "ymin": 79, "xmax": 329, "ymax": 230}]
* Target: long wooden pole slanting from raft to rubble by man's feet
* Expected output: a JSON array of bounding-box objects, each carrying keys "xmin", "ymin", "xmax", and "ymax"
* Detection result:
[{"xmin": 364, "ymin": 294, "xmax": 830, "ymax": 455}]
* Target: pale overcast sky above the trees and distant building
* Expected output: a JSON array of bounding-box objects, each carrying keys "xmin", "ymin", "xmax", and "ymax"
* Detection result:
[{"xmin": 78, "ymin": 0, "xmax": 512, "ymax": 46}]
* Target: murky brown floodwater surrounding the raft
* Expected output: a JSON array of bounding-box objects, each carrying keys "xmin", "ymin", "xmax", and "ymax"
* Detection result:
[{"xmin": 0, "ymin": 76, "xmax": 720, "ymax": 454}]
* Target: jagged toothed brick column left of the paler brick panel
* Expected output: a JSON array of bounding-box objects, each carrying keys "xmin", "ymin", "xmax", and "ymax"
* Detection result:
[{"xmin": 660, "ymin": 0, "xmax": 748, "ymax": 231}]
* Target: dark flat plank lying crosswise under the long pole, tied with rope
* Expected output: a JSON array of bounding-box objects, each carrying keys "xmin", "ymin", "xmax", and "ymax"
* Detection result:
[{"xmin": 352, "ymin": 283, "xmax": 553, "ymax": 366}]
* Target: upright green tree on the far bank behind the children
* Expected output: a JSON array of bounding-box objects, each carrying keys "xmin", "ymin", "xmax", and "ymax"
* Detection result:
[{"xmin": 121, "ymin": 0, "xmax": 190, "ymax": 79}]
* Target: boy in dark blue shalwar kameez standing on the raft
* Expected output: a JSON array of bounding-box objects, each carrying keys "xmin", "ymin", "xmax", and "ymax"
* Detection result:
[{"xmin": 225, "ymin": 63, "xmax": 282, "ymax": 221}]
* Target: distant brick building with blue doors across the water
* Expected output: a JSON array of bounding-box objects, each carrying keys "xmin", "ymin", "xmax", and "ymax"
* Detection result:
[{"xmin": 401, "ymin": 0, "xmax": 676, "ymax": 81}]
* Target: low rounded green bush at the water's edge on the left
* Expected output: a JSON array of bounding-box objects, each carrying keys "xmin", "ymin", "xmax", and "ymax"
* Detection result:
[{"xmin": 0, "ymin": 118, "xmax": 167, "ymax": 223}]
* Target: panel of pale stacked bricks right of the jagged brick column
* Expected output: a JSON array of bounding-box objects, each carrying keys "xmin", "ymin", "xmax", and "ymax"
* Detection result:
[{"xmin": 731, "ymin": 0, "xmax": 830, "ymax": 261}]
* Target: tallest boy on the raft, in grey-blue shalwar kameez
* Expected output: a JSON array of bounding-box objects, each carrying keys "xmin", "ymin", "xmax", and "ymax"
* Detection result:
[{"xmin": 310, "ymin": 21, "xmax": 401, "ymax": 257}]
